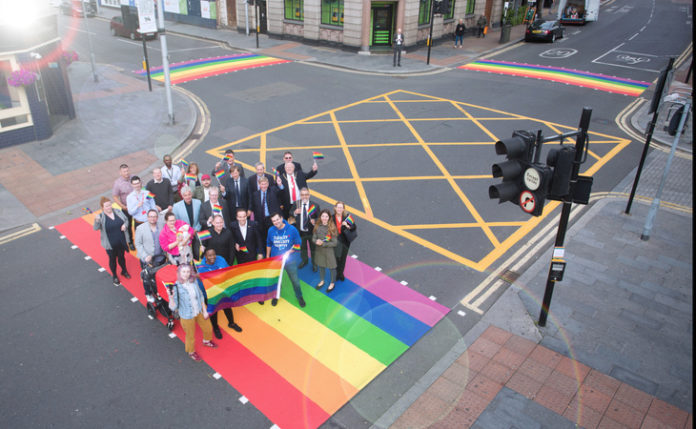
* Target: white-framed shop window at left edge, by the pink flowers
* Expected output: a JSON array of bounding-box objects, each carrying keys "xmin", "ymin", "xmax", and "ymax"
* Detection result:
[{"xmin": 0, "ymin": 58, "xmax": 31, "ymax": 132}]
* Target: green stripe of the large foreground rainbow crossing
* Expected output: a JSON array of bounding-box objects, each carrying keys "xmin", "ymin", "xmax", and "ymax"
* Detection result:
[{"xmin": 281, "ymin": 275, "xmax": 408, "ymax": 365}]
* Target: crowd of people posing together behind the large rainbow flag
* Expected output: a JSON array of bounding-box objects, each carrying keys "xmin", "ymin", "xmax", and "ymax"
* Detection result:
[{"xmin": 94, "ymin": 150, "xmax": 357, "ymax": 360}]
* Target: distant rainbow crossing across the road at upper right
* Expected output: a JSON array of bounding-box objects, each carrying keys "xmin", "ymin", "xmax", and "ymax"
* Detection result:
[{"xmin": 459, "ymin": 60, "xmax": 650, "ymax": 97}]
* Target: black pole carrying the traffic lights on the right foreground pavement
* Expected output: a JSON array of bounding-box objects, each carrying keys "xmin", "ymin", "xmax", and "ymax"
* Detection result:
[{"xmin": 539, "ymin": 107, "xmax": 592, "ymax": 326}]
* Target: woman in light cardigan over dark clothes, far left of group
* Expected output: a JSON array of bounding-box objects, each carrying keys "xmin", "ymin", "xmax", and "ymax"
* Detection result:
[{"xmin": 94, "ymin": 197, "xmax": 130, "ymax": 286}]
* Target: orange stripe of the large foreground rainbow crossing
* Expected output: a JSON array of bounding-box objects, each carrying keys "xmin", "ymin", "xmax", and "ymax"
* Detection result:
[{"xmin": 220, "ymin": 304, "xmax": 358, "ymax": 414}]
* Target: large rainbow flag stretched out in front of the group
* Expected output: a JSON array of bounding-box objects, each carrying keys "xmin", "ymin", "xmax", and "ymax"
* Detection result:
[{"xmin": 199, "ymin": 255, "xmax": 283, "ymax": 314}]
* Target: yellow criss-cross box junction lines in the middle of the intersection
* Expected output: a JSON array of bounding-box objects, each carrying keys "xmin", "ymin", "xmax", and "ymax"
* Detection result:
[{"xmin": 207, "ymin": 90, "xmax": 631, "ymax": 271}]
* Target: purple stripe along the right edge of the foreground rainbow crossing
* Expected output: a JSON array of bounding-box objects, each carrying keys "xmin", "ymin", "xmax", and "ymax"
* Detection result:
[{"xmin": 345, "ymin": 257, "xmax": 450, "ymax": 327}]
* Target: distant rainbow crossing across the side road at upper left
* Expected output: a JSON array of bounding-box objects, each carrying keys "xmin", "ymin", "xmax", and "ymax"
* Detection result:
[{"xmin": 136, "ymin": 54, "xmax": 291, "ymax": 85}]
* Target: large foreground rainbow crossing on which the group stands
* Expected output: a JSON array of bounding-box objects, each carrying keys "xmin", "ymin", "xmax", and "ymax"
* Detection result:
[{"xmin": 56, "ymin": 213, "xmax": 449, "ymax": 429}]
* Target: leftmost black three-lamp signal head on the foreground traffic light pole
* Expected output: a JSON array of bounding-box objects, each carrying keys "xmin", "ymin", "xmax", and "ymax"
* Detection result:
[{"xmin": 488, "ymin": 130, "xmax": 536, "ymax": 204}]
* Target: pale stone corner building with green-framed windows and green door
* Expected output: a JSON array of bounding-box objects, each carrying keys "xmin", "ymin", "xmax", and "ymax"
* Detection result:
[{"xmin": 228, "ymin": 0, "xmax": 520, "ymax": 52}]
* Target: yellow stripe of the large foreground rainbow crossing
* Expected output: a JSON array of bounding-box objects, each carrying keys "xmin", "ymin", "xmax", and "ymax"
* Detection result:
[{"xmin": 246, "ymin": 299, "xmax": 386, "ymax": 390}]
